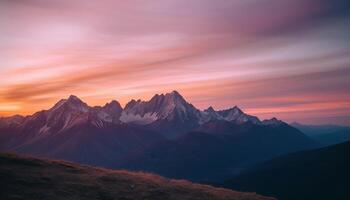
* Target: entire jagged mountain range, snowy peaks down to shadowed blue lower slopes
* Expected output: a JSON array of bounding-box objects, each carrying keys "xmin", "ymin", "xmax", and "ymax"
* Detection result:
[{"xmin": 0, "ymin": 91, "xmax": 318, "ymax": 181}]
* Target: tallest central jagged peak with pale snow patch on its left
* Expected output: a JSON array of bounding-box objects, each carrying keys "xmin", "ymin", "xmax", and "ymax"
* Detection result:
[{"xmin": 120, "ymin": 91, "xmax": 201, "ymax": 138}]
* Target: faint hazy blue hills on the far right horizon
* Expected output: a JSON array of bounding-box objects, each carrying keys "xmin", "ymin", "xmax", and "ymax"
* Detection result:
[{"xmin": 291, "ymin": 123, "xmax": 350, "ymax": 146}]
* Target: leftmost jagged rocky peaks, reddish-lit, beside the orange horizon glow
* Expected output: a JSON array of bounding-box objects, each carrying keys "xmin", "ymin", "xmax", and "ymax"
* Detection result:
[{"xmin": 0, "ymin": 95, "xmax": 122, "ymax": 136}]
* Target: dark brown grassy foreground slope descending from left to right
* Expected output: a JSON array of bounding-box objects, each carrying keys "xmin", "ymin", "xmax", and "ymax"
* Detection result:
[{"xmin": 0, "ymin": 154, "xmax": 272, "ymax": 200}]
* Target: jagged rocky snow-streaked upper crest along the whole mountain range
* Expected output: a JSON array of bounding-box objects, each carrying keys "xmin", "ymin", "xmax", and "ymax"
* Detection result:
[{"xmin": 0, "ymin": 91, "xmax": 284, "ymax": 137}]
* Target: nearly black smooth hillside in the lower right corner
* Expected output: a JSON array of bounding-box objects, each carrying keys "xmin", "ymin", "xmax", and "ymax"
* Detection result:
[{"xmin": 224, "ymin": 142, "xmax": 350, "ymax": 200}]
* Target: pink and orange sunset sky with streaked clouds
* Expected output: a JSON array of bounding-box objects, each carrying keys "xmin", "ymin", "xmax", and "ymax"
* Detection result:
[{"xmin": 0, "ymin": 0, "xmax": 350, "ymax": 125}]
